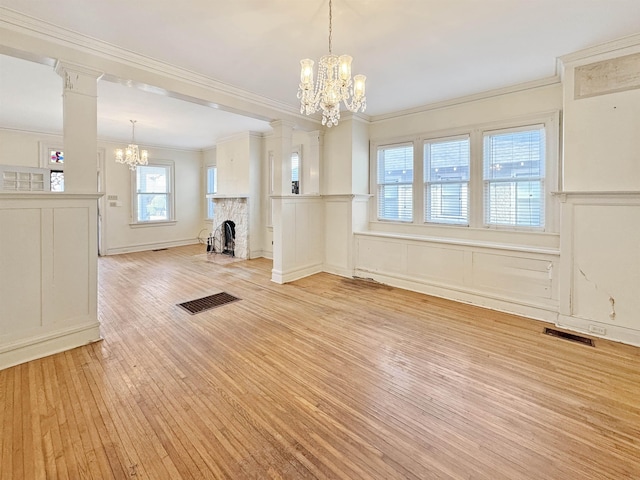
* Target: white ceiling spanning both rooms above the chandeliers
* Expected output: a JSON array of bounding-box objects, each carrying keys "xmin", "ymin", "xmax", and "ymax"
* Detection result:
[{"xmin": 0, "ymin": 0, "xmax": 640, "ymax": 148}]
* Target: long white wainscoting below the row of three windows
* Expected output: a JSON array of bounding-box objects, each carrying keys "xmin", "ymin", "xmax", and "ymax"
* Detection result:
[{"xmin": 355, "ymin": 232, "xmax": 559, "ymax": 322}]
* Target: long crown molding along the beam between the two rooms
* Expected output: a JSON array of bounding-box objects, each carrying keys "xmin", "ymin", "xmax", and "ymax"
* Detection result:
[{"xmin": 0, "ymin": 6, "xmax": 316, "ymax": 121}]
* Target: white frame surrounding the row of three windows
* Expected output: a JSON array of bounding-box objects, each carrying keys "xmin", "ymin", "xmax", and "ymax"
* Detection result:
[{"xmin": 369, "ymin": 110, "xmax": 562, "ymax": 234}]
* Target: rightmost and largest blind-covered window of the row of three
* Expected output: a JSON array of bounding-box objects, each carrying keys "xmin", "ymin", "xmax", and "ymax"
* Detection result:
[{"xmin": 483, "ymin": 126, "xmax": 546, "ymax": 227}]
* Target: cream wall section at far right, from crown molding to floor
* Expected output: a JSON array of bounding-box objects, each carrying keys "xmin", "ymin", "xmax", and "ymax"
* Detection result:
[{"xmin": 559, "ymin": 36, "xmax": 640, "ymax": 345}]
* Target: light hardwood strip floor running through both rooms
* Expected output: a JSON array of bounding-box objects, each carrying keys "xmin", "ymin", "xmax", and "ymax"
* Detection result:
[{"xmin": 0, "ymin": 246, "xmax": 640, "ymax": 480}]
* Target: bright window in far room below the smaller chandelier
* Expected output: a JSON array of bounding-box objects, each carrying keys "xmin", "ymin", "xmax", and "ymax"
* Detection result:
[{"xmin": 136, "ymin": 165, "xmax": 171, "ymax": 222}]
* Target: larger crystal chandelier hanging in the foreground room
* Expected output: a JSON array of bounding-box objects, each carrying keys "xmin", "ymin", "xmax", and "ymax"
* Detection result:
[{"xmin": 298, "ymin": 0, "xmax": 367, "ymax": 127}]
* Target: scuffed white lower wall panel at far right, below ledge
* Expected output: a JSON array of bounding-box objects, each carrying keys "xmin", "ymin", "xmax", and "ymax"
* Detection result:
[{"xmin": 559, "ymin": 192, "xmax": 640, "ymax": 345}]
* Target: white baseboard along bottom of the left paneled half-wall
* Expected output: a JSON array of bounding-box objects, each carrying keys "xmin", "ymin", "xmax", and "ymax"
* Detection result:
[{"xmin": 0, "ymin": 321, "xmax": 102, "ymax": 370}]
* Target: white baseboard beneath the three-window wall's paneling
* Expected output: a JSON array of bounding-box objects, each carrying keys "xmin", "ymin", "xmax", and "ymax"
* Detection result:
[{"xmin": 354, "ymin": 268, "xmax": 558, "ymax": 324}]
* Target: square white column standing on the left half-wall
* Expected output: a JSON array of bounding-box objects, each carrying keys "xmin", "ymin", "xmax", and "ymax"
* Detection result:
[{"xmin": 56, "ymin": 61, "xmax": 102, "ymax": 193}]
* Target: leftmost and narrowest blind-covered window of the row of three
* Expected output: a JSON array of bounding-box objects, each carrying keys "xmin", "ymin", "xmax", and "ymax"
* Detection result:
[{"xmin": 377, "ymin": 144, "xmax": 413, "ymax": 222}]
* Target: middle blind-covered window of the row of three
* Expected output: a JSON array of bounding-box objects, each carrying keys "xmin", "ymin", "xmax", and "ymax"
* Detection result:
[{"xmin": 424, "ymin": 136, "xmax": 470, "ymax": 225}]
